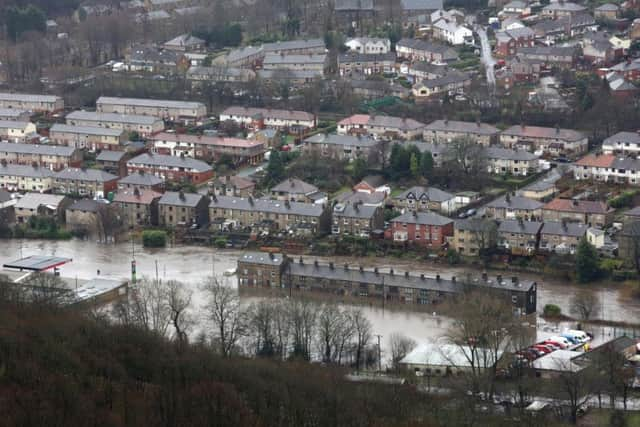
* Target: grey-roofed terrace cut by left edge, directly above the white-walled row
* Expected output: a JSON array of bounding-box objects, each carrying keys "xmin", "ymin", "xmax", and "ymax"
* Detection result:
[{"xmin": 0, "ymin": 142, "xmax": 82, "ymax": 171}]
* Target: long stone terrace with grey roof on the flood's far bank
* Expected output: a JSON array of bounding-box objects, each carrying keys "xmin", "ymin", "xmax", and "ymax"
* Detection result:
[{"xmin": 209, "ymin": 196, "xmax": 331, "ymax": 234}]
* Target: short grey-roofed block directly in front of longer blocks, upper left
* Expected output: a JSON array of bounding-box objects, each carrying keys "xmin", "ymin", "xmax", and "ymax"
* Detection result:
[{"xmin": 49, "ymin": 123, "xmax": 125, "ymax": 151}]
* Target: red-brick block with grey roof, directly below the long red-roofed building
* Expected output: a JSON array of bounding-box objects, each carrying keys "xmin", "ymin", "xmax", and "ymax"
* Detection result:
[{"xmin": 127, "ymin": 153, "xmax": 213, "ymax": 185}]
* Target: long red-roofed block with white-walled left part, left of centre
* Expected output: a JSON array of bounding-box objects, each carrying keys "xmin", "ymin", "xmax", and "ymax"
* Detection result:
[{"xmin": 151, "ymin": 132, "xmax": 266, "ymax": 166}]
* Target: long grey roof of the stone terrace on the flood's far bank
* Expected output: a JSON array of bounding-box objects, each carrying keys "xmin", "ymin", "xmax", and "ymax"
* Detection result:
[{"xmin": 209, "ymin": 196, "xmax": 324, "ymax": 217}]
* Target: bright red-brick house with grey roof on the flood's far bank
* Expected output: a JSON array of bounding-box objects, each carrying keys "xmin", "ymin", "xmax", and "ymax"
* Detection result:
[{"xmin": 385, "ymin": 212, "xmax": 453, "ymax": 249}]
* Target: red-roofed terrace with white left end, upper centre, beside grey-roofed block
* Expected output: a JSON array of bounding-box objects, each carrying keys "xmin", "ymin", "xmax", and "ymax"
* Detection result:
[{"xmin": 337, "ymin": 114, "xmax": 425, "ymax": 139}]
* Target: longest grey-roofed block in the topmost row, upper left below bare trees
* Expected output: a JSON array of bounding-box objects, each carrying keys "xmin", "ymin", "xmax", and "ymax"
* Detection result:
[{"xmin": 96, "ymin": 96, "xmax": 207, "ymax": 122}]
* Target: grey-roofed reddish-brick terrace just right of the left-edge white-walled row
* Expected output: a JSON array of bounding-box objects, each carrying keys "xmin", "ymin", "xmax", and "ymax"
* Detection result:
[{"xmin": 54, "ymin": 168, "xmax": 119, "ymax": 198}]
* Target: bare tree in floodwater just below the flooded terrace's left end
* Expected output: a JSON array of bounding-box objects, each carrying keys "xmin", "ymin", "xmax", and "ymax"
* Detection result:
[{"xmin": 203, "ymin": 277, "xmax": 245, "ymax": 357}]
